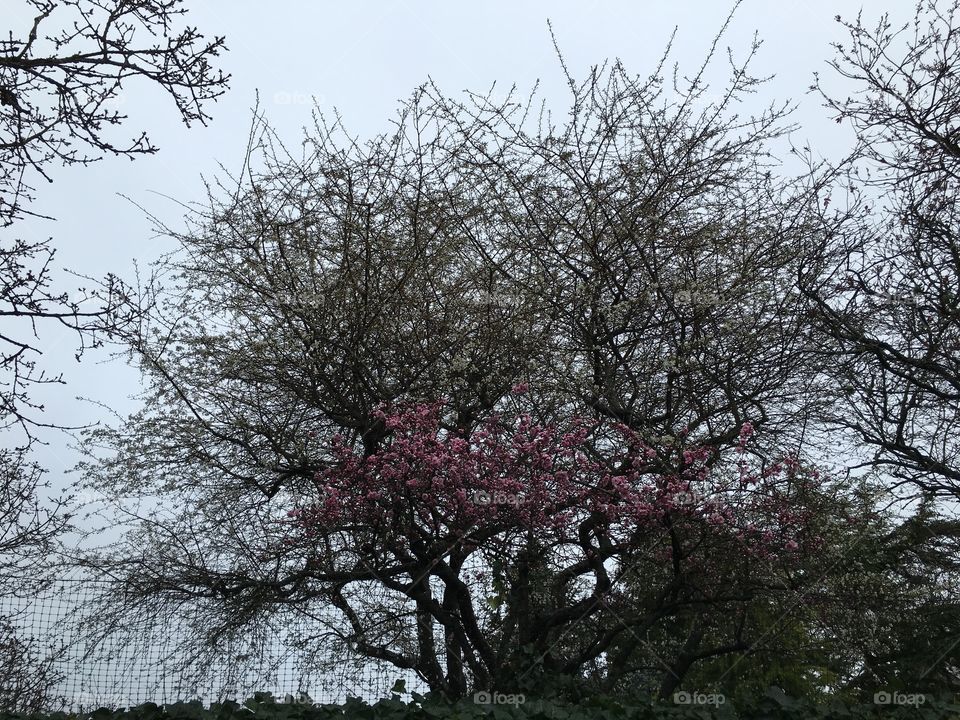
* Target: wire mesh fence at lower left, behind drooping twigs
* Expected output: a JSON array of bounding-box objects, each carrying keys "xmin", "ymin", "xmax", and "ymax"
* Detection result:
[{"xmin": 0, "ymin": 577, "xmax": 426, "ymax": 712}]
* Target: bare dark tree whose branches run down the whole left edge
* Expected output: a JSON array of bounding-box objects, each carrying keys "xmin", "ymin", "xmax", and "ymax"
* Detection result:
[{"xmin": 0, "ymin": 0, "xmax": 228, "ymax": 708}]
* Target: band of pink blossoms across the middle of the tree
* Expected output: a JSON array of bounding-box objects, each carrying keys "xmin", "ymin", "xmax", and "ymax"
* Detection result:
[{"xmin": 291, "ymin": 401, "xmax": 818, "ymax": 557}]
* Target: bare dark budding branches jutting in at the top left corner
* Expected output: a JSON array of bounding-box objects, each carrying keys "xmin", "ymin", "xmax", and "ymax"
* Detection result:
[{"xmin": 0, "ymin": 0, "xmax": 229, "ymax": 225}]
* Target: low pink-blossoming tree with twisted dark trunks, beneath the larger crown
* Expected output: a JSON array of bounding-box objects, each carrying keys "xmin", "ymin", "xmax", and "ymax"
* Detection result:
[{"xmin": 285, "ymin": 402, "xmax": 848, "ymax": 696}]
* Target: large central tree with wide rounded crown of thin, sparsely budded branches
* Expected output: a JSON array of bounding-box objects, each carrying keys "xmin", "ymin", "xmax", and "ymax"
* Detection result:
[{"xmin": 67, "ymin": 4, "xmax": 949, "ymax": 696}]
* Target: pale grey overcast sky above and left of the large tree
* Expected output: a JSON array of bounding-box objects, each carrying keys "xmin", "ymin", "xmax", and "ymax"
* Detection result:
[{"xmin": 2, "ymin": 0, "xmax": 924, "ymax": 544}]
